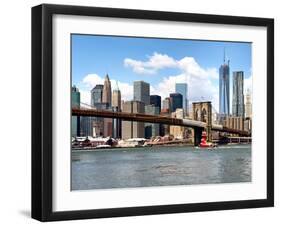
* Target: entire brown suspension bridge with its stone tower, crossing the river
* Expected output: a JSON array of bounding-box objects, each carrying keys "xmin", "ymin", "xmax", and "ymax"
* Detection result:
[{"xmin": 72, "ymin": 101, "xmax": 251, "ymax": 145}]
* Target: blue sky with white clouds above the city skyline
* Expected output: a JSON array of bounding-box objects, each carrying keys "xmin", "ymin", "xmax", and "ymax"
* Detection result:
[{"xmin": 72, "ymin": 35, "xmax": 251, "ymax": 111}]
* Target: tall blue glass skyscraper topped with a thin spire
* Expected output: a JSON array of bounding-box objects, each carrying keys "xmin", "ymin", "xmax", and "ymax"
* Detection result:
[{"xmin": 219, "ymin": 54, "xmax": 229, "ymax": 116}]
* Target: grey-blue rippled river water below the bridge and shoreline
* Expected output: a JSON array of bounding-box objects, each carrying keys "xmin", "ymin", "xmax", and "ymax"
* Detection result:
[{"xmin": 71, "ymin": 145, "xmax": 251, "ymax": 190}]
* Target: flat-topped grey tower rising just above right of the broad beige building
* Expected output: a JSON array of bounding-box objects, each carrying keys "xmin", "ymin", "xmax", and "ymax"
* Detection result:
[{"xmin": 134, "ymin": 81, "xmax": 150, "ymax": 105}]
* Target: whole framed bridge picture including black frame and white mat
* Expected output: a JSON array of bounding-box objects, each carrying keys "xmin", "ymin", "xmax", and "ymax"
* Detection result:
[{"xmin": 32, "ymin": 4, "xmax": 274, "ymax": 221}]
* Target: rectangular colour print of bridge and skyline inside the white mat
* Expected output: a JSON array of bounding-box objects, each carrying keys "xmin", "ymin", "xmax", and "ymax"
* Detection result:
[{"xmin": 71, "ymin": 35, "xmax": 252, "ymax": 190}]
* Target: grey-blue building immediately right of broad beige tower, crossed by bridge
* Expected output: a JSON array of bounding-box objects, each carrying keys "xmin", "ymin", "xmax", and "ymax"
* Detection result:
[{"xmin": 144, "ymin": 102, "xmax": 161, "ymax": 139}]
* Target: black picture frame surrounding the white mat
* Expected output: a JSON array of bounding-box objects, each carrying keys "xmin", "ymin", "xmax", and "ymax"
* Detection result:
[{"xmin": 32, "ymin": 4, "xmax": 274, "ymax": 221}]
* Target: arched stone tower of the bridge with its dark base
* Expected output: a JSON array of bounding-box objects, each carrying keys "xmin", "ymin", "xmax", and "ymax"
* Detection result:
[{"xmin": 192, "ymin": 101, "xmax": 212, "ymax": 145}]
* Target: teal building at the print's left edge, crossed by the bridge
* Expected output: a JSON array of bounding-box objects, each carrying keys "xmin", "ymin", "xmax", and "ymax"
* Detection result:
[{"xmin": 71, "ymin": 85, "xmax": 80, "ymax": 137}]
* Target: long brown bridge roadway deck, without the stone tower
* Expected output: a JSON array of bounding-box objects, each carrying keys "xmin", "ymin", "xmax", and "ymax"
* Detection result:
[{"xmin": 72, "ymin": 108, "xmax": 250, "ymax": 136}]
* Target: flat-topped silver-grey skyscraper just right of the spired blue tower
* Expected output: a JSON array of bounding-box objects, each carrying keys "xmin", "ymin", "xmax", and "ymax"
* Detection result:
[{"xmin": 232, "ymin": 71, "xmax": 244, "ymax": 117}]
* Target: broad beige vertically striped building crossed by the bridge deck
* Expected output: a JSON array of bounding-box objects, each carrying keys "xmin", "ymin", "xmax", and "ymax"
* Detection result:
[{"xmin": 122, "ymin": 101, "xmax": 144, "ymax": 139}]
